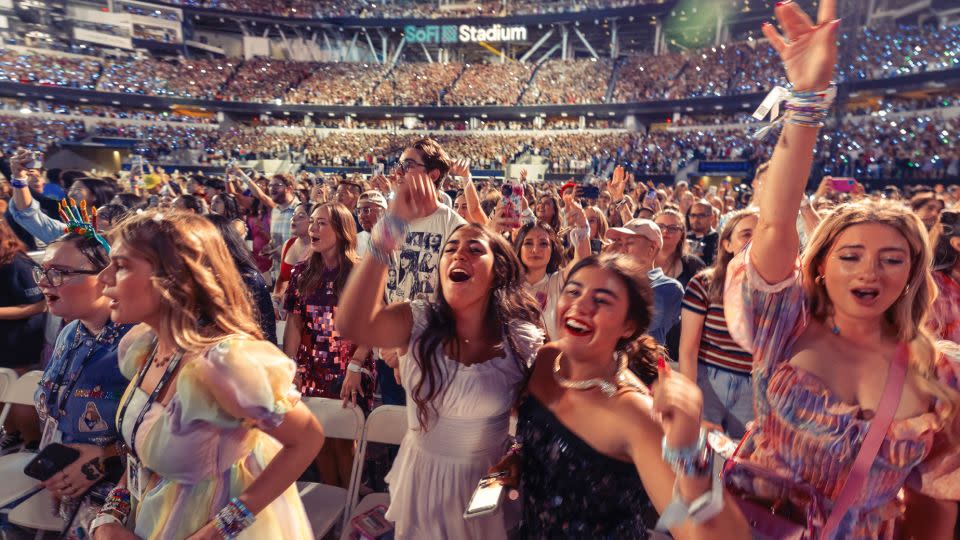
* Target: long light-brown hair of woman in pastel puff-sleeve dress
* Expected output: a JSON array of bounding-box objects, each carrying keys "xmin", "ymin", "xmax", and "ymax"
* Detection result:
[{"xmin": 110, "ymin": 210, "xmax": 263, "ymax": 352}]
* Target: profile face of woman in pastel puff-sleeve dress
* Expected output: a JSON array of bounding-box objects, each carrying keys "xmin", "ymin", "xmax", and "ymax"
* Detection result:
[{"xmin": 98, "ymin": 238, "xmax": 161, "ymax": 328}]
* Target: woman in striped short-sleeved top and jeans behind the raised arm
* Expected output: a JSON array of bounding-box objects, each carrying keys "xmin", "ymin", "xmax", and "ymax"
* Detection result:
[{"xmin": 679, "ymin": 210, "xmax": 757, "ymax": 439}]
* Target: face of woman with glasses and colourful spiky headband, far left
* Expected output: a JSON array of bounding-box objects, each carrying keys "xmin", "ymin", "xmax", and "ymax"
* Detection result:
[{"xmin": 37, "ymin": 240, "xmax": 107, "ymax": 320}]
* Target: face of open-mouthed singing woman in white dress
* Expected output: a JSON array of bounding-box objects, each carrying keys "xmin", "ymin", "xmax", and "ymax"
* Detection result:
[{"xmin": 440, "ymin": 228, "xmax": 494, "ymax": 311}]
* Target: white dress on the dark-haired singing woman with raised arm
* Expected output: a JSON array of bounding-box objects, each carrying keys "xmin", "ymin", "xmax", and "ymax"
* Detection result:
[{"xmin": 386, "ymin": 301, "xmax": 543, "ymax": 540}]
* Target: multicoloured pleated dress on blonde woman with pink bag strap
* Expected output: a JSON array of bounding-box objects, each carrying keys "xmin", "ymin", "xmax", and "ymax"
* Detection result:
[{"xmin": 724, "ymin": 248, "xmax": 960, "ymax": 540}]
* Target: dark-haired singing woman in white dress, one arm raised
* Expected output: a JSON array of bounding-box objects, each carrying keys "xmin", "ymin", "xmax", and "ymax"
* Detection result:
[{"xmin": 338, "ymin": 174, "xmax": 543, "ymax": 539}]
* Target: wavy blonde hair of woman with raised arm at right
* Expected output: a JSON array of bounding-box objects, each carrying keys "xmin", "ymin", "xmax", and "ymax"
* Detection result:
[{"xmin": 801, "ymin": 200, "xmax": 960, "ymax": 440}]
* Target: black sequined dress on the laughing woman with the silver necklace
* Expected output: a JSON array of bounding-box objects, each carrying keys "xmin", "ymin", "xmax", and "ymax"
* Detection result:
[{"xmin": 517, "ymin": 394, "xmax": 657, "ymax": 540}]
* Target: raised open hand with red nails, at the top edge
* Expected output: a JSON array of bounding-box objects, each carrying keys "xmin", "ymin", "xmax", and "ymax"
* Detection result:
[{"xmin": 763, "ymin": 0, "xmax": 840, "ymax": 92}]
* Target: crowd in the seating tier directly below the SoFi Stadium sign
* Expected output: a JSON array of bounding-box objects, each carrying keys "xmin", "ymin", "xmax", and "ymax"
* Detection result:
[{"xmin": 0, "ymin": 21, "xmax": 960, "ymax": 105}]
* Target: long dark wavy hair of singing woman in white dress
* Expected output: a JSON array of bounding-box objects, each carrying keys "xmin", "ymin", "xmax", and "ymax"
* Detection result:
[{"xmin": 412, "ymin": 224, "xmax": 543, "ymax": 431}]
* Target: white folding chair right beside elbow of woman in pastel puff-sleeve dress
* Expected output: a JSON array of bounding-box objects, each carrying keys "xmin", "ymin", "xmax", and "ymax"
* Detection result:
[{"xmin": 300, "ymin": 398, "xmax": 364, "ymax": 538}]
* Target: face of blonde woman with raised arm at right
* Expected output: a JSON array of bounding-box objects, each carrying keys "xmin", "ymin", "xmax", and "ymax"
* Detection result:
[{"xmin": 819, "ymin": 223, "xmax": 911, "ymax": 319}]
